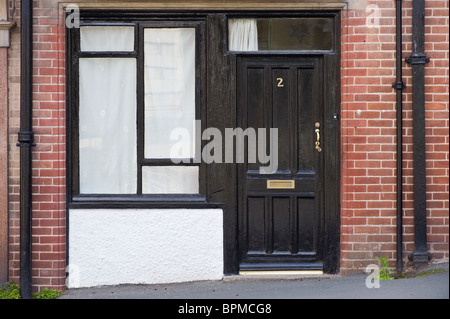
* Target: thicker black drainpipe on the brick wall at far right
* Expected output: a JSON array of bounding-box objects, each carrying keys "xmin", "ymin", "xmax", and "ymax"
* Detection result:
[{"xmin": 406, "ymin": 0, "xmax": 431, "ymax": 268}]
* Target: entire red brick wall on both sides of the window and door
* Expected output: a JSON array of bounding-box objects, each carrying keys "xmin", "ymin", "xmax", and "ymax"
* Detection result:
[{"xmin": 8, "ymin": 0, "xmax": 449, "ymax": 290}]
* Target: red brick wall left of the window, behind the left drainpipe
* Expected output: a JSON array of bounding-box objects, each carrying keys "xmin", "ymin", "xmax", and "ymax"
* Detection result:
[{"xmin": 9, "ymin": 1, "xmax": 66, "ymax": 291}]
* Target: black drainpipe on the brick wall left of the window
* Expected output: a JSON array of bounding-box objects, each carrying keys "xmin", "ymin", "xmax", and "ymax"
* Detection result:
[{"xmin": 17, "ymin": 0, "xmax": 34, "ymax": 299}]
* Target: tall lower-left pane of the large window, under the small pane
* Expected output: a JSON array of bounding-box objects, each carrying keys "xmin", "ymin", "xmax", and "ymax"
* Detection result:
[{"xmin": 79, "ymin": 58, "xmax": 137, "ymax": 194}]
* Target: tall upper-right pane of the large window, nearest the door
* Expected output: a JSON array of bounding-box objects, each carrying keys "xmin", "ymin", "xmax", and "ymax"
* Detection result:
[{"xmin": 144, "ymin": 28, "xmax": 195, "ymax": 158}]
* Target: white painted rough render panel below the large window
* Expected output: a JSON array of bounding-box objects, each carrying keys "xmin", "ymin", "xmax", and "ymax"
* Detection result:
[{"xmin": 67, "ymin": 209, "xmax": 223, "ymax": 288}]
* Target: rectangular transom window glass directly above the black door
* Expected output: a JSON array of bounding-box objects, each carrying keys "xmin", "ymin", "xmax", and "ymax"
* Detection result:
[{"xmin": 228, "ymin": 18, "xmax": 333, "ymax": 51}]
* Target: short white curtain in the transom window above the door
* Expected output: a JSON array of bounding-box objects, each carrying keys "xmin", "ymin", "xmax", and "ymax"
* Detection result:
[{"xmin": 228, "ymin": 19, "xmax": 258, "ymax": 51}]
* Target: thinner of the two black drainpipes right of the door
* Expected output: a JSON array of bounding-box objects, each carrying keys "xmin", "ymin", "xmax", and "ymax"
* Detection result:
[{"xmin": 392, "ymin": 0, "xmax": 405, "ymax": 273}]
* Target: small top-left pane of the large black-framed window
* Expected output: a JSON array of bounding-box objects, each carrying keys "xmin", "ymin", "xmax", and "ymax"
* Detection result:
[{"xmin": 80, "ymin": 26, "xmax": 134, "ymax": 51}]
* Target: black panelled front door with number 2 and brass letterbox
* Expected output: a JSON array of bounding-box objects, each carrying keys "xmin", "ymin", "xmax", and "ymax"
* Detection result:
[{"xmin": 237, "ymin": 56, "xmax": 327, "ymax": 271}]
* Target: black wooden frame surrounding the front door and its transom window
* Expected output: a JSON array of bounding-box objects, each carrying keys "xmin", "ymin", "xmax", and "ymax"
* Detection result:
[{"xmin": 201, "ymin": 10, "xmax": 341, "ymax": 275}]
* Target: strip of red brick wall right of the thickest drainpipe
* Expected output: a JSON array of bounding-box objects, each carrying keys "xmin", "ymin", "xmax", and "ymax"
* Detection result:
[{"xmin": 422, "ymin": 0, "xmax": 449, "ymax": 259}]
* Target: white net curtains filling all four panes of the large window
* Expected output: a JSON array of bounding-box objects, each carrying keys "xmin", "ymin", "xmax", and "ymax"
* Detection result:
[{"xmin": 79, "ymin": 26, "xmax": 199, "ymax": 194}]
